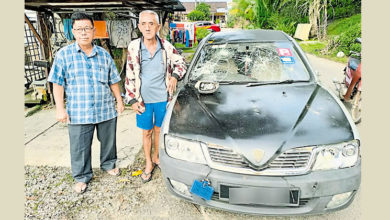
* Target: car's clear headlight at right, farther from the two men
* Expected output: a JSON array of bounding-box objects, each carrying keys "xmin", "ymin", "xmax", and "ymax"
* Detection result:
[{"xmin": 313, "ymin": 140, "xmax": 360, "ymax": 170}]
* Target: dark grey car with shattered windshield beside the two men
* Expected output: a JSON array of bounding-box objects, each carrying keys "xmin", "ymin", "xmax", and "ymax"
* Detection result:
[{"xmin": 160, "ymin": 30, "xmax": 361, "ymax": 215}]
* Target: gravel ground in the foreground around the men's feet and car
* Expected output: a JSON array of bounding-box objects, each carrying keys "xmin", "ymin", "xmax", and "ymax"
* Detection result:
[{"xmin": 24, "ymin": 150, "xmax": 360, "ymax": 220}]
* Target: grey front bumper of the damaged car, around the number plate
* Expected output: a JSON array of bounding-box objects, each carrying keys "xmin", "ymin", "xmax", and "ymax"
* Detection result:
[{"xmin": 160, "ymin": 150, "xmax": 361, "ymax": 215}]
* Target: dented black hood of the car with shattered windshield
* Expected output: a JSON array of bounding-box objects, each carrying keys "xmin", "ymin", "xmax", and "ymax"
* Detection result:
[{"xmin": 168, "ymin": 83, "xmax": 354, "ymax": 166}]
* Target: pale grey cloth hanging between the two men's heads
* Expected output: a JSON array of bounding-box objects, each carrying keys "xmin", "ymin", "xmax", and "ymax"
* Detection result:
[{"xmin": 107, "ymin": 20, "xmax": 133, "ymax": 48}]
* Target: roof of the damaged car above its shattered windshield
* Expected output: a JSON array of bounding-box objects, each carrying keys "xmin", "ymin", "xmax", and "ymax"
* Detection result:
[{"xmin": 208, "ymin": 29, "xmax": 290, "ymax": 43}]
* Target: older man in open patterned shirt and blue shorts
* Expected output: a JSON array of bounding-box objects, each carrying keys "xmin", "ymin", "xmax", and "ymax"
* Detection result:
[{"xmin": 125, "ymin": 10, "xmax": 186, "ymax": 182}]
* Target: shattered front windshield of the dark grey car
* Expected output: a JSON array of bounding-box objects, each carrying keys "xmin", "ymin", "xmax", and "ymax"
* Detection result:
[{"xmin": 190, "ymin": 42, "xmax": 310, "ymax": 82}]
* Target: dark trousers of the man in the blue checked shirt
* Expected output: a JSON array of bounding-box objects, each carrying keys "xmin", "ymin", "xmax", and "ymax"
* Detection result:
[{"xmin": 68, "ymin": 118, "xmax": 117, "ymax": 183}]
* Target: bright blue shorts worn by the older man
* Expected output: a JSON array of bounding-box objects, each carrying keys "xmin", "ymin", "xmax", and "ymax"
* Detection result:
[{"xmin": 136, "ymin": 101, "xmax": 167, "ymax": 130}]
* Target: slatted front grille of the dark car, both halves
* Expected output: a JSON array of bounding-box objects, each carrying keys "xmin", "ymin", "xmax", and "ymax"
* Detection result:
[{"xmin": 208, "ymin": 145, "xmax": 312, "ymax": 174}]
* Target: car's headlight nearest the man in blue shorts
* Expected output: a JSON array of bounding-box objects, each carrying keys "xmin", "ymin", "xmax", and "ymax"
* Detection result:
[{"xmin": 165, "ymin": 135, "xmax": 206, "ymax": 164}]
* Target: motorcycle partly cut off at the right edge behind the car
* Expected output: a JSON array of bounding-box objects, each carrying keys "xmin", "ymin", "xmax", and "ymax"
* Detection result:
[{"xmin": 333, "ymin": 38, "xmax": 362, "ymax": 124}]
